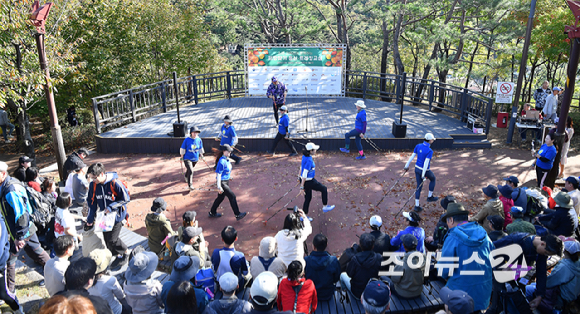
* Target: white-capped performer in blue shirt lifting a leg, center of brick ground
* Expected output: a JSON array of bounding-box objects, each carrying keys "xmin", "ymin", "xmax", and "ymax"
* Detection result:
[{"xmin": 300, "ymin": 142, "xmax": 335, "ymax": 220}]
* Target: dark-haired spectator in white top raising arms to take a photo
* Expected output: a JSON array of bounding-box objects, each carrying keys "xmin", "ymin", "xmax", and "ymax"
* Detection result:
[{"xmin": 275, "ymin": 209, "xmax": 312, "ymax": 266}]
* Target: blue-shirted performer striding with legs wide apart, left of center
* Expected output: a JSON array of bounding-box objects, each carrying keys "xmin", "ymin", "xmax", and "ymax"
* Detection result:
[{"xmin": 209, "ymin": 144, "xmax": 247, "ymax": 220}]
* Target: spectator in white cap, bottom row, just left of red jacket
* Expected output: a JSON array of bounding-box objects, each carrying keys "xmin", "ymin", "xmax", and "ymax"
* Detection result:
[{"xmin": 249, "ymin": 271, "xmax": 292, "ymax": 314}]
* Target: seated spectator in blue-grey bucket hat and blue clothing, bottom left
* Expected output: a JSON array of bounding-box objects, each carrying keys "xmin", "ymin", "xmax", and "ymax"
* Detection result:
[{"xmin": 161, "ymin": 256, "xmax": 209, "ymax": 313}]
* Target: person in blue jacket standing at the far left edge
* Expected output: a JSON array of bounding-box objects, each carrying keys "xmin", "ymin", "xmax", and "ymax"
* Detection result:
[{"xmin": 0, "ymin": 161, "xmax": 50, "ymax": 293}]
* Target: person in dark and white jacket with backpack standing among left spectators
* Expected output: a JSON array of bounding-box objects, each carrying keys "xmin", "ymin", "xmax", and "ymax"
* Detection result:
[{"xmin": 87, "ymin": 162, "xmax": 131, "ymax": 270}]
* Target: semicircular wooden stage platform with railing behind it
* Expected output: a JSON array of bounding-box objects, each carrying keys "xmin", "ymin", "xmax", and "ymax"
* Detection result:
[{"xmin": 96, "ymin": 97, "xmax": 489, "ymax": 154}]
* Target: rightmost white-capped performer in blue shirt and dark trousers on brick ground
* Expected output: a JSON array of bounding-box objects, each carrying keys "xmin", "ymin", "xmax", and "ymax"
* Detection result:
[{"xmin": 404, "ymin": 133, "xmax": 439, "ymax": 212}]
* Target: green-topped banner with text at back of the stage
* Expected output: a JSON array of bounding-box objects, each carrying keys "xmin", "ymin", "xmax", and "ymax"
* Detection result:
[{"xmin": 247, "ymin": 47, "xmax": 345, "ymax": 96}]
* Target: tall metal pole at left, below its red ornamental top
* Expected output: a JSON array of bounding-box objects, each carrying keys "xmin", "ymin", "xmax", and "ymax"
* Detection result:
[{"xmin": 34, "ymin": 33, "xmax": 66, "ymax": 181}]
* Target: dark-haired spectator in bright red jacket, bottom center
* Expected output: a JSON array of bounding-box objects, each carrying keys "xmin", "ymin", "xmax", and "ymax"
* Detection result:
[{"xmin": 278, "ymin": 261, "xmax": 318, "ymax": 314}]
